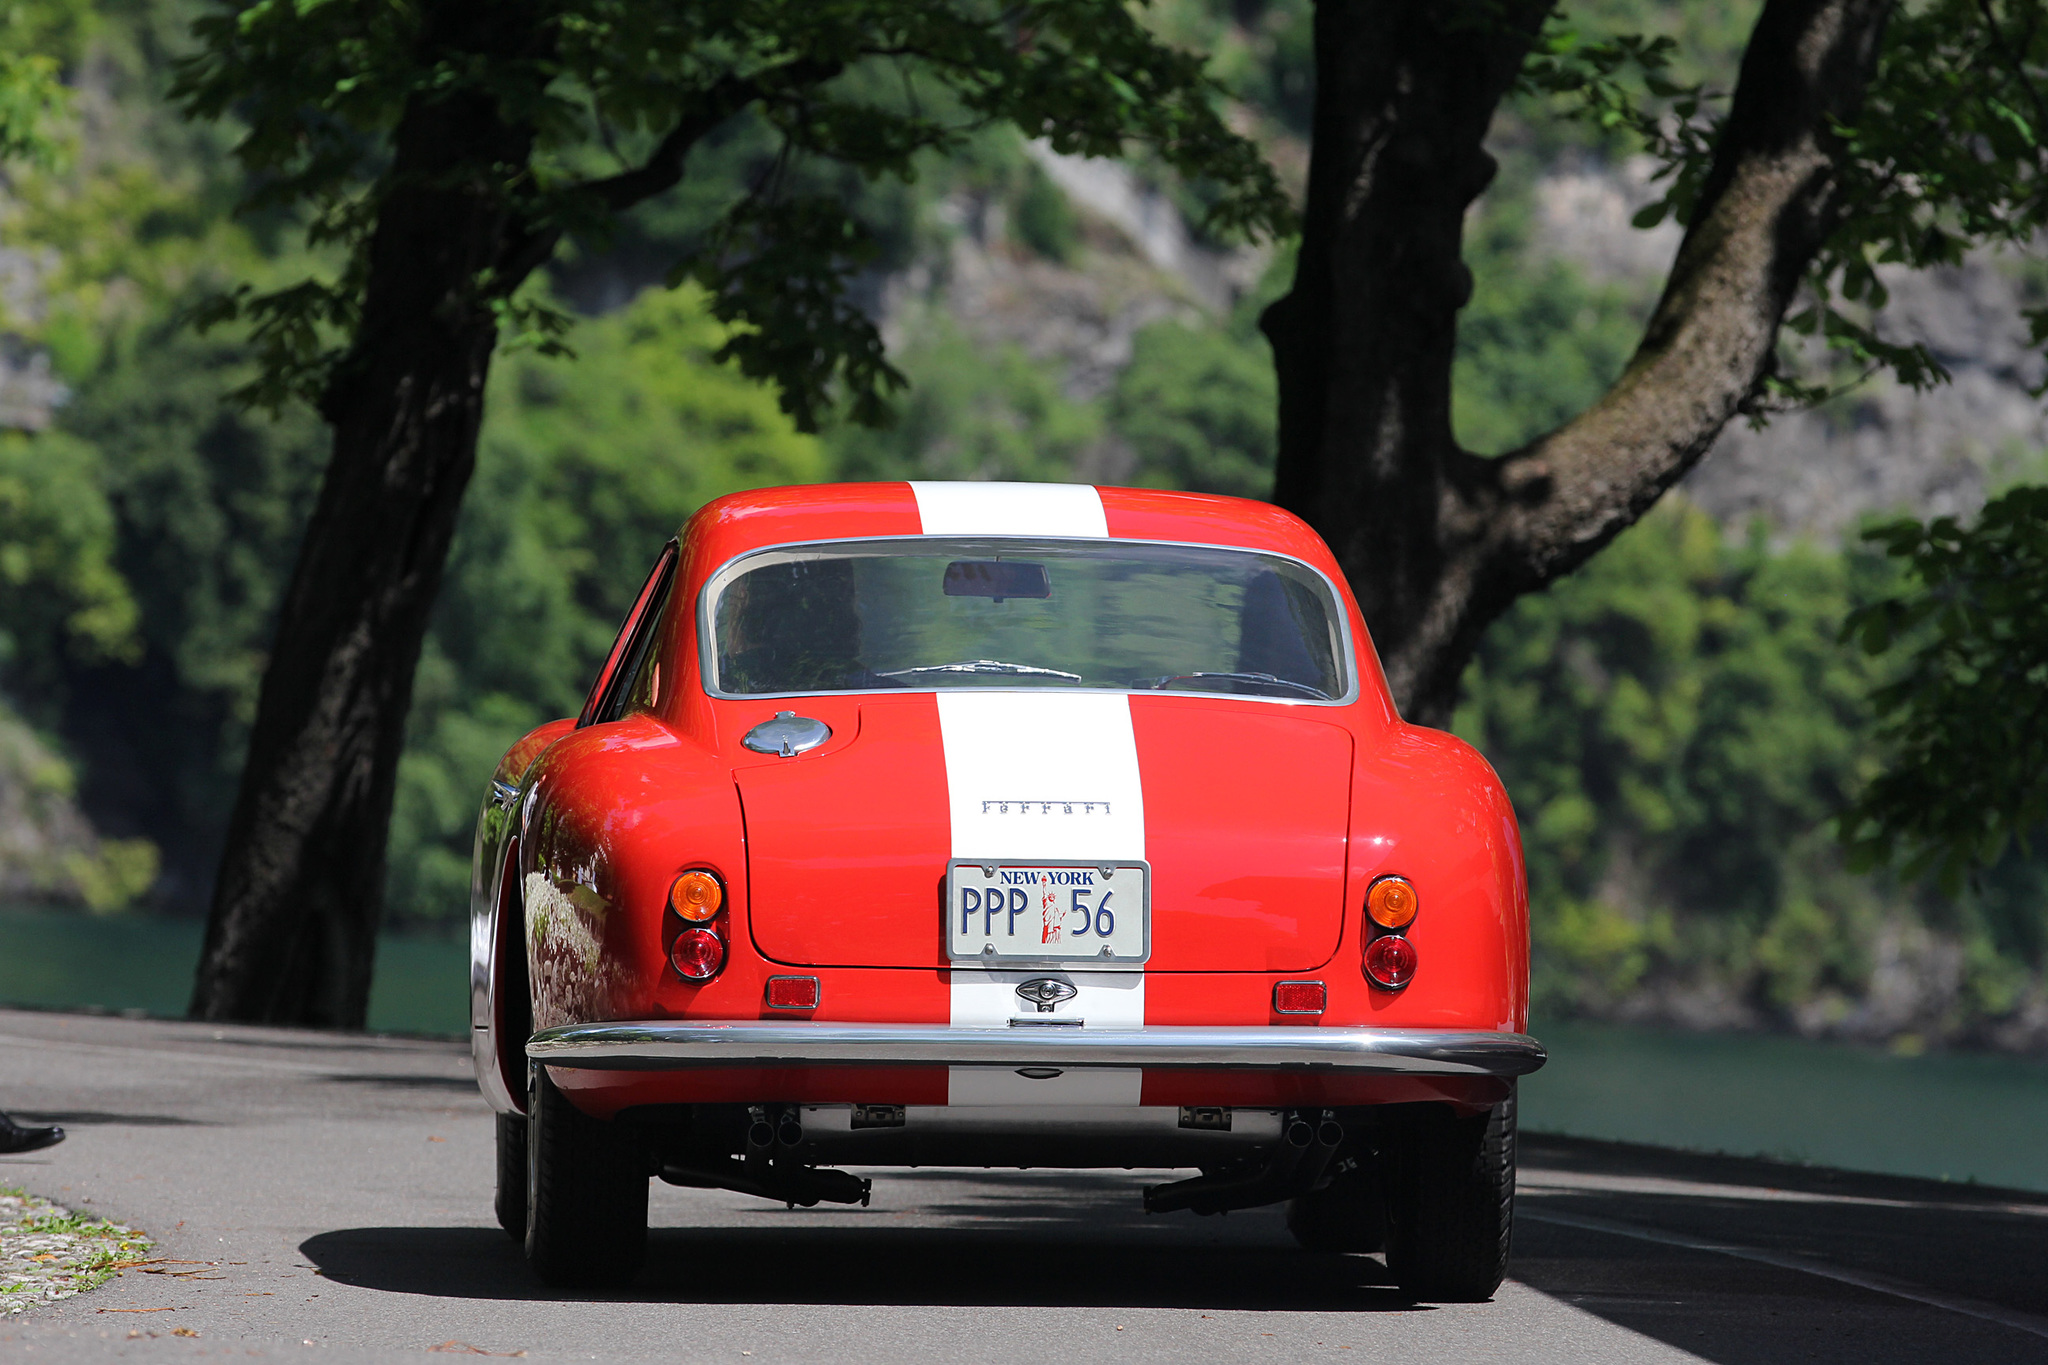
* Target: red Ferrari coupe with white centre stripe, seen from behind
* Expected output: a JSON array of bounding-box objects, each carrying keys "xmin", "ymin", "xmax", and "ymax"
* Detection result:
[{"xmin": 471, "ymin": 483, "xmax": 1544, "ymax": 1300}]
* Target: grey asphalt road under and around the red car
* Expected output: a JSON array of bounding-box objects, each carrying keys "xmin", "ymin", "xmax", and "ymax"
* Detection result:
[{"xmin": 0, "ymin": 1011, "xmax": 2048, "ymax": 1365}]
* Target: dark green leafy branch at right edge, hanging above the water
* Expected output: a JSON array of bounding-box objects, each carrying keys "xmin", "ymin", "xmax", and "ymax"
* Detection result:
[{"xmin": 1841, "ymin": 487, "xmax": 2048, "ymax": 888}]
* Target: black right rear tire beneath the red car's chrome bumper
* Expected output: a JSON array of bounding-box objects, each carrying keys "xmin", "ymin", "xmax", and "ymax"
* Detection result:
[{"xmin": 1386, "ymin": 1093, "xmax": 1516, "ymax": 1304}]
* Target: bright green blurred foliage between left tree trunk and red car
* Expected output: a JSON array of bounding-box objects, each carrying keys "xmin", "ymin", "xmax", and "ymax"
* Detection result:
[{"xmin": 387, "ymin": 289, "xmax": 827, "ymax": 923}]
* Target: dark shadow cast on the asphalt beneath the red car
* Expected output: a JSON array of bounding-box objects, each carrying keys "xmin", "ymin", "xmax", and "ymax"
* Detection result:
[{"xmin": 299, "ymin": 1224, "xmax": 1415, "ymax": 1312}]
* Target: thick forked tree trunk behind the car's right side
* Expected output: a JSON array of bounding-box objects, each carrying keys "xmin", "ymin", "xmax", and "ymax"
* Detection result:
[{"xmin": 1262, "ymin": 0, "xmax": 1892, "ymax": 724}]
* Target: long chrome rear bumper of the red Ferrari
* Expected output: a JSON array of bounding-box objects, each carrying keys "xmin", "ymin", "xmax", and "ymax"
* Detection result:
[{"xmin": 526, "ymin": 1019, "xmax": 1544, "ymax": 1078}]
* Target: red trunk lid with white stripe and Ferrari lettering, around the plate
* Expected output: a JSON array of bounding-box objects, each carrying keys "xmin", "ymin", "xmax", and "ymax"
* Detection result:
[{"xmin": 735, "ymin": 692, "xmax": 1352, "ymax": 972}]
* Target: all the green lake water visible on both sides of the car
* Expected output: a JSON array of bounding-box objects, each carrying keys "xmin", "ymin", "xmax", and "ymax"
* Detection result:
[{"xmin": 0, "ymin": 909, "xmax": 2048, "ymax": 1189}]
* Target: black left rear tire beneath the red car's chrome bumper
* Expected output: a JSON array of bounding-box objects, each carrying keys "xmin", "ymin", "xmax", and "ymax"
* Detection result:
[{"xmin": 526, "ymin": 1066, "xmax": 649, "ymax": 1289}]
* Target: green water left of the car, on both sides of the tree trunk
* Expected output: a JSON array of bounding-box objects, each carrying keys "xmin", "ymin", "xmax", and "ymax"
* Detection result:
[{"xmin": 0, "ymin": 909, "xmax": 469, "ymax": 1033}]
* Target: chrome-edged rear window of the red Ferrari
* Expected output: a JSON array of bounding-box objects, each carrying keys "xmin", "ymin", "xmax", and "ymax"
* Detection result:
[{"xmin": 707, "ymin": 536, "xmax": 1350, "ymax": 702}]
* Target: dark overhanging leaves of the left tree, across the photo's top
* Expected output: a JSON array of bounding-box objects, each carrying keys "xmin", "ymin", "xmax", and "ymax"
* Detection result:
[{"xmin": 176, "ymin": 0, "xmax": 1288, "ymax": 430}]
